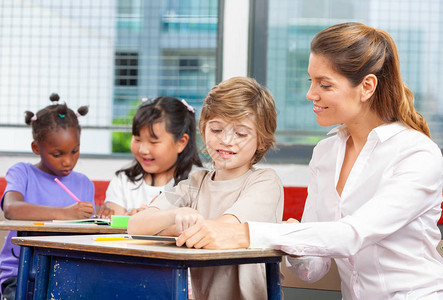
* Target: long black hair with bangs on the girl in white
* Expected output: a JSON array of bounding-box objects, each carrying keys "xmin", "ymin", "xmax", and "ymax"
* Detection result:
[{"xmin": 116, "ymin": 97, "xmax": 202, "ymax": 185}]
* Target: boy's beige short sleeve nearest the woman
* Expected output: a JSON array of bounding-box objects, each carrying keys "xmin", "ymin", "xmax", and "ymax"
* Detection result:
[{"xmin": 225, "ymin": 169, "xmax": 284, "ymax": 223}]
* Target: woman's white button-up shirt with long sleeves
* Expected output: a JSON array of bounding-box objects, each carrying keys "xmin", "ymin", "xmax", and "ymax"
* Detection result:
[{"xmin": 249, "ymin": 123, "xmax": 443, "ymax": 300}]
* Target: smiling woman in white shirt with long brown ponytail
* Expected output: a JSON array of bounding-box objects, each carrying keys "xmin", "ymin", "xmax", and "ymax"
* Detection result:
[{"xmin": 177, "ymin": 23, "xmax": 443, "ymax": 299}]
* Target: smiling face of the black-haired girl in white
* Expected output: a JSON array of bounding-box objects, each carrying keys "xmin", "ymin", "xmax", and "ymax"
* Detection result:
[{"xmin": 131, "ymin": 122, "xmax": 189, "ymax": 181}]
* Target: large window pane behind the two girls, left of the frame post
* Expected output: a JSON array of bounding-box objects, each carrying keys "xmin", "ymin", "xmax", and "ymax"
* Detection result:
[{"xmin": 0, "ymin": 0, "xmax": 219, "ymax": 153}]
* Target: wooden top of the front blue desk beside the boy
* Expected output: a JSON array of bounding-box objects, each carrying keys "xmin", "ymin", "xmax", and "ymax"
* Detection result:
[{"xmin": 12, "ymin": 234, "xmax": 285, "ymax": 261}]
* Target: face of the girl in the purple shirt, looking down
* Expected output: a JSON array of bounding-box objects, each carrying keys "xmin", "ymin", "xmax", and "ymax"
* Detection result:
[{"xmin": 31, "ymin": 128, "xmax": 80, "ymax": 177}]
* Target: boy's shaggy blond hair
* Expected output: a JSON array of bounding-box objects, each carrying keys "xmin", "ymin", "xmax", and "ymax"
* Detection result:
[{"xmin": 198, "ymin": 77, "xmax": 277, "ymax": 166}]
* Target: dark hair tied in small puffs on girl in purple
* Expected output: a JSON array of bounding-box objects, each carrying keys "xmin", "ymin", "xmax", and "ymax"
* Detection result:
[{"xmin": 25, "ymin": 93, "xmax": 88, "ymax": 143}]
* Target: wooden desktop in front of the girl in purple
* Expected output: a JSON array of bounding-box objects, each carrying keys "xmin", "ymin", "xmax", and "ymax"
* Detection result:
[{"xmin": 0, "ymin": 220, "xmax": 126, "ymax": 234}]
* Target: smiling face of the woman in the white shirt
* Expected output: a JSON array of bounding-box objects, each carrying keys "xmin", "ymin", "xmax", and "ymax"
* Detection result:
[{"xmin": 306, "ymin": 54, "xmax": 369, "ymax": 126}]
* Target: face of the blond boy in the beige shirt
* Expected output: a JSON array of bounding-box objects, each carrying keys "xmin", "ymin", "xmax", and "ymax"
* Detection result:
[{"xmin": 205, "ymin": 117, "xmax": 257, "ymax": 180}]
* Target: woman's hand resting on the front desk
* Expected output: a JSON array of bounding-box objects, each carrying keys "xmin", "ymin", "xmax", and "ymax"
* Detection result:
[{"xmin": 176, "ymin": 220, "xmax": 249, "ymax": 249}]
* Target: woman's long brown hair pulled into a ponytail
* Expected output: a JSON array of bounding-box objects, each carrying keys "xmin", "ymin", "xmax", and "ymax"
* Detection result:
[{"xmin": 311, "ymin": 23, "xmax": 430, "ymax": 136}]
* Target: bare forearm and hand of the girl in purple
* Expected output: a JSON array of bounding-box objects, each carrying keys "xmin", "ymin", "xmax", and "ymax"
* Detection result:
[{"xmin": 3, "ymin": 191, "xmax": 94, "ymax": 220}]
